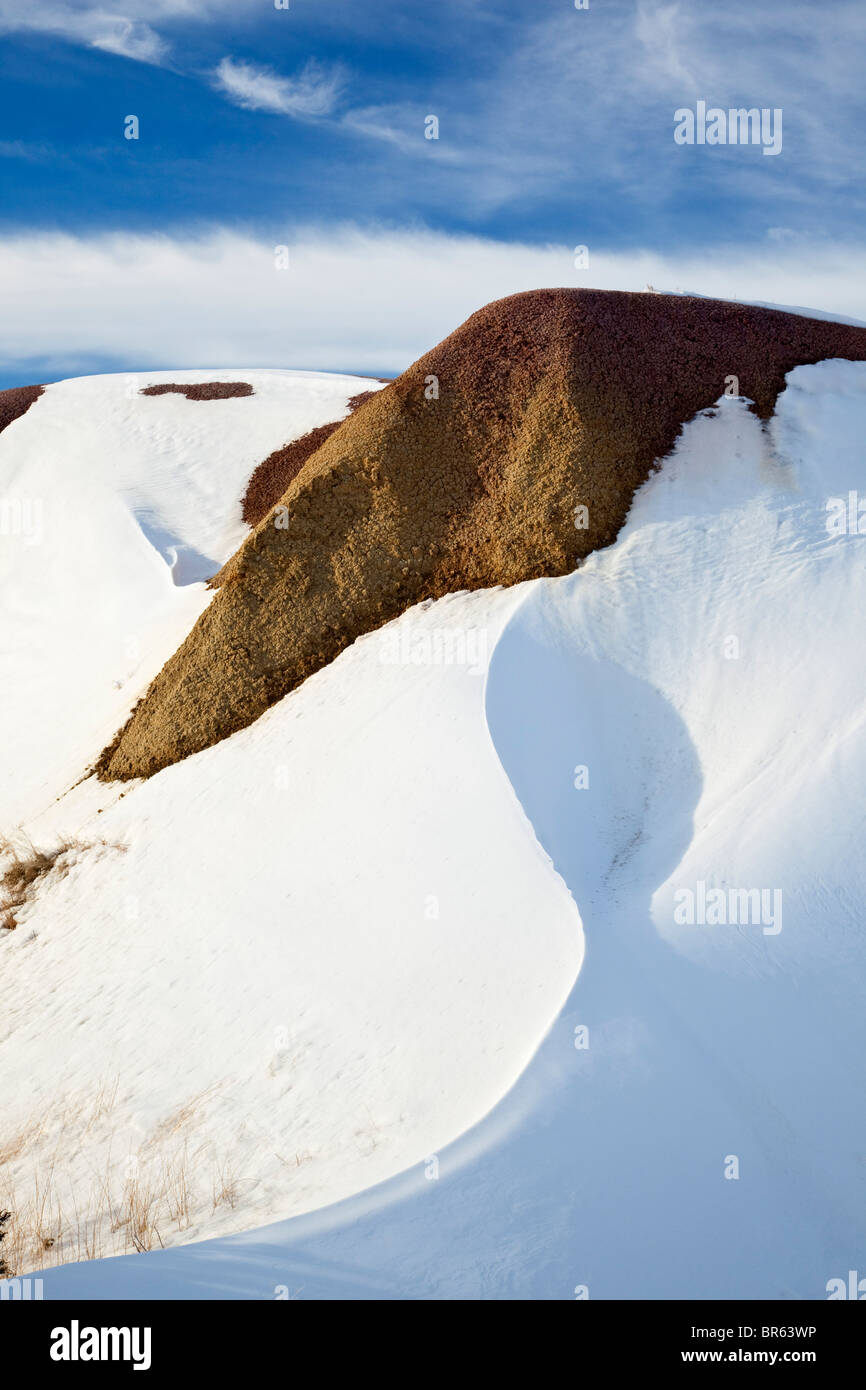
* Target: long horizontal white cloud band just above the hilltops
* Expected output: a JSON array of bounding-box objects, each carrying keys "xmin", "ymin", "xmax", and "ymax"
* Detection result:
[{"xmin": 0, "ymin": 227, "xmax": 866, "ymax": 375}]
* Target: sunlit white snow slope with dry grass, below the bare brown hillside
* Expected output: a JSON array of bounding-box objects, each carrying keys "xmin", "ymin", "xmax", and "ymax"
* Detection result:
[{"xmin": 0, "ymin": 382, "xmax": 582, "ymax": 1262}]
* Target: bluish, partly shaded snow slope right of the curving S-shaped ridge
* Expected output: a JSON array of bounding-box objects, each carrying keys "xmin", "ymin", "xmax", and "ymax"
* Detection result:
[{"xmin": 32, "ymin": 363, "xmax": 866, "ymax": 1298}]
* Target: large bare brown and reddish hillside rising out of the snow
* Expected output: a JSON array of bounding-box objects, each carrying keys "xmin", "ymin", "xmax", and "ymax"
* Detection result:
[{"xmin": 97, "ymin": 289, "xmax": 866, "ymax": 778}]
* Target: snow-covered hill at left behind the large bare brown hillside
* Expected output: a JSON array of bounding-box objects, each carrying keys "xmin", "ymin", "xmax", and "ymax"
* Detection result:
[{"xmin": 0, "ymin": 370, "xmax": 378, "ymax": 834}]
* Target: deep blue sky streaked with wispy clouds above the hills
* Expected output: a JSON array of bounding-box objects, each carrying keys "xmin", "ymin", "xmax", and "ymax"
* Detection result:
[{"xmin": 0, "ymin": 0, "xmax": 866, "ymax": 381}]
